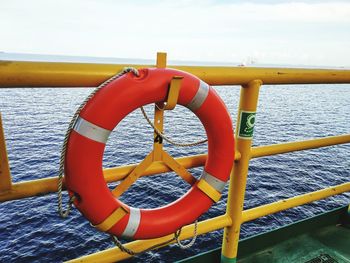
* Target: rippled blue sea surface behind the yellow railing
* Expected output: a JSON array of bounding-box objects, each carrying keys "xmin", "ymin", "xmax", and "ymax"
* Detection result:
[{"xmin": 0, "ymin": 81, "xmax": 350, "ymax": 262}]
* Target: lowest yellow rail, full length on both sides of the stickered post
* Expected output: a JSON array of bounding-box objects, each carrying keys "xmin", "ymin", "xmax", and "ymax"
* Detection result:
[{"xmin": 68, "ymin": 183, "xmax": 350, "ymax": 263}]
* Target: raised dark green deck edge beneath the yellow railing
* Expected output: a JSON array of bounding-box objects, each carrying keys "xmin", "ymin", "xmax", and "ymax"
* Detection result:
[{"xmin": 177, "ymin": 206, "xmax": 350, "ymax": 263}]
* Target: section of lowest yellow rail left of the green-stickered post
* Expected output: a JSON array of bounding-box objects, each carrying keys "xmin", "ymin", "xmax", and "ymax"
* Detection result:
[{"xmin": 68, "ymin": 215, "xmax": 232, "ymax": 263}]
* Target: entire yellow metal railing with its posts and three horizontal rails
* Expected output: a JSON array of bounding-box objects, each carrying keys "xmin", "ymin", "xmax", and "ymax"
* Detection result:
[{"xmin": 0, "ymin": 56, "xmax": 350, "ymax": 262}]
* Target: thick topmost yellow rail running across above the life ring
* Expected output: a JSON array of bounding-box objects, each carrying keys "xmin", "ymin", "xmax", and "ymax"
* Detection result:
[{"xmin": 0, "ymin": 61, "xmax": 350, "ymax": 87}]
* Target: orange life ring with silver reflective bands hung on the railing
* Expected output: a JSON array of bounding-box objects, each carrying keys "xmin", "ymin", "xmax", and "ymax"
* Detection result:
[{"xmin": 65, "ymin": 69, "xmax": 234, "ymax": 239}]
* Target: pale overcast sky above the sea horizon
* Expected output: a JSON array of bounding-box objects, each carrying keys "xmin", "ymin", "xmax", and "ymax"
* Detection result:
[{"xmin": 0, "ymin": 0, "xmax": 350, "ymax": 66}]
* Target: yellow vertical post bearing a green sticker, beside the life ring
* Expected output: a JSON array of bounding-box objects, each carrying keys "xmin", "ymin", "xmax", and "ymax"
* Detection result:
[{"xmin": 221, "ymin": 80, "xmax": 262, "ymax": 263}]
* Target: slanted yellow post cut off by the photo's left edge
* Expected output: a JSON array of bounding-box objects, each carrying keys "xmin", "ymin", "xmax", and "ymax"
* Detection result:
[{"xmin": 0, "ymin": 113, "xmax": 12, "ymax": 192}]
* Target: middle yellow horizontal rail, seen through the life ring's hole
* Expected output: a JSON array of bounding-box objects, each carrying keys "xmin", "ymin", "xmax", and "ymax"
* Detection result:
[{"xmin": 0, "ymin": 134, "xmax": 350, "ymax": 202}]
